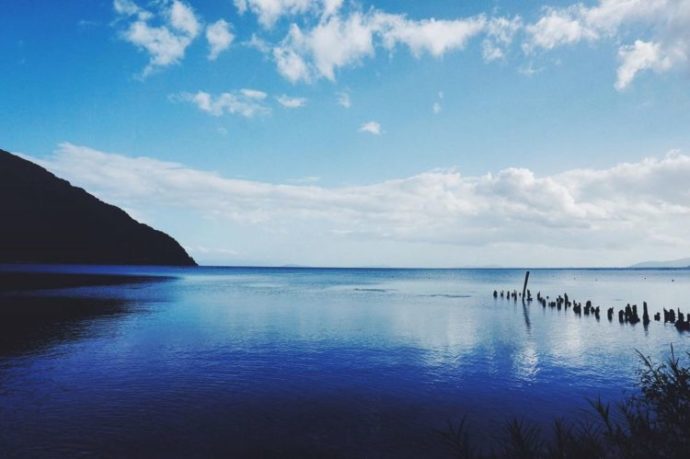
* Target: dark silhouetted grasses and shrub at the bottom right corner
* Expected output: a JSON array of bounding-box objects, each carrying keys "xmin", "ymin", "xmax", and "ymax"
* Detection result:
[{"xmin": 438, "ymin": 348, "xmax": 690, "ymax": 459}]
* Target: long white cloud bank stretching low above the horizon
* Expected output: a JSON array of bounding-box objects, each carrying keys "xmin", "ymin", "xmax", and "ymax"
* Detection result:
[{"xmin": 30, "ymin": 143, "xmax": 690, "ymax": 258}]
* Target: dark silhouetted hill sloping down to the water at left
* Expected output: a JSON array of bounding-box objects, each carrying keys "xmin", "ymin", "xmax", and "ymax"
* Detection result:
[{"xmin": 0, "ymin": 150, "xmax": 196, "ymax": 266}]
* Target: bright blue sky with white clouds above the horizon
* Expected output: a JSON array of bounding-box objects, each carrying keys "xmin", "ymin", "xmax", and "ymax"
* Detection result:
[{"xmin": 0, "ymin": 0, "xmax": 690, "ymax": 267}]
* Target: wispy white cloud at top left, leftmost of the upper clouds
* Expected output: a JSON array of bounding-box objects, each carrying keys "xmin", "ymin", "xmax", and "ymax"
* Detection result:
[{"xmin": 113, "ymin": 0, "xmax": 200, "ymax": 76}]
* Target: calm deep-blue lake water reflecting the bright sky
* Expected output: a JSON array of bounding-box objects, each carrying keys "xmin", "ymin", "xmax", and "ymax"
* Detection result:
[{"xmin": 0, "ymin": 267, "xmax": 690, "ymax": 457}]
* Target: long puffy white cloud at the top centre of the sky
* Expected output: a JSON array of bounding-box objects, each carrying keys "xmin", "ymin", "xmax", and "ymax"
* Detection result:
[{"xmin": 272, "ymin": 8, "xmax": 521, "ymax": 83}]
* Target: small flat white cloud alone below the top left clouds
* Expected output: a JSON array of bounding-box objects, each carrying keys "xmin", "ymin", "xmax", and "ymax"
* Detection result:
[{"xmin": 171, "ymin": 89, "xmax": 271, "ymax": 118}]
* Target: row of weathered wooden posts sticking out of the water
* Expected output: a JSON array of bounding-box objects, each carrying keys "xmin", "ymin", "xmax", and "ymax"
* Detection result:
[{"xmin": 493, "ymin": 271, "xmax": 690, "ymax": 331}]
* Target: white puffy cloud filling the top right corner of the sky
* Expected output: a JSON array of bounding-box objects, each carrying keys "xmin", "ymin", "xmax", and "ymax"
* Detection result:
[{"xmin": 523, "ymin": 0, "xmax": 690, "ymax": 90}]
